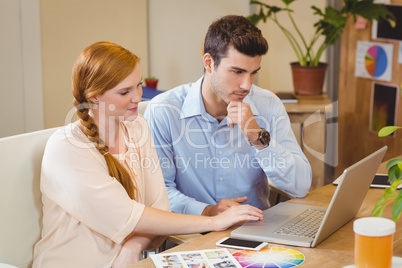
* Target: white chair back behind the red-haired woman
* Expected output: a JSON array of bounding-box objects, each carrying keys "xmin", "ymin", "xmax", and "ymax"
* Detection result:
[{"xmin": 0, "ymin": 128, "xmax": 56, "ymax": 268}]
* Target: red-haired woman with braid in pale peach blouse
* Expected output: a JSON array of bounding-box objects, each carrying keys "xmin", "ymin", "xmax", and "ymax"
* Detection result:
[{"xmin": 33, "ymin": 42, "xmax": 262, "ymax": 268}]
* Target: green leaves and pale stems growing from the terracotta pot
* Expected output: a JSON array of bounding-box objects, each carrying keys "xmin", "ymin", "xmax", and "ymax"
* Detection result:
[{"xmin": 247, "ymin": 0, "xmax": 395, "ymax": 66}]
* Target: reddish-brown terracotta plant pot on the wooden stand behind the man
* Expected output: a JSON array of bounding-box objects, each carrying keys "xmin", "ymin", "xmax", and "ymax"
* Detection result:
[{"xmin": 290, "ymin": 62, "xmax": 328, "ymax": 95}]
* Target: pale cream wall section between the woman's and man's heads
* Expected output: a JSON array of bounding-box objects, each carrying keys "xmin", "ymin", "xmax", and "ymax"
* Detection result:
[{"xmin": 148, "ymin": 0, "xmax": 250, "ymax": 90}]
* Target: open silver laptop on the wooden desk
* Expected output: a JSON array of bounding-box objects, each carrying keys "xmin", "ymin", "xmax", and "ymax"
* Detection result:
[{"xmin": 231, "ymin": 146, "xmax": 388, "ymax": 247}]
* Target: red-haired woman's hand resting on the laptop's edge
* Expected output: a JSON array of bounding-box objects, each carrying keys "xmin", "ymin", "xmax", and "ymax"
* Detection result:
[{"xmin": 212, "ymin": 205, "xmax": 262, "ymax": 231}]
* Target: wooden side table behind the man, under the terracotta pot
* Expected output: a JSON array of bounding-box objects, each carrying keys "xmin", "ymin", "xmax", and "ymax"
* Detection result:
[{"xmin": 284, "ymin": 94, "xmax": 333, "ymax": 190}]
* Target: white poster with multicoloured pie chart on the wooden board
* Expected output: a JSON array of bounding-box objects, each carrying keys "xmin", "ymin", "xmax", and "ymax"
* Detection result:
[{"xmin": 355, "ymin": 41, "xmax": 394, "ymax": 82}]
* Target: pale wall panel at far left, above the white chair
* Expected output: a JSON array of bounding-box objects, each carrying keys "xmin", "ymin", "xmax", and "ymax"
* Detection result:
[{"xmin": 0, "ymin": 0, "xmax": 44, "ymax": 137}]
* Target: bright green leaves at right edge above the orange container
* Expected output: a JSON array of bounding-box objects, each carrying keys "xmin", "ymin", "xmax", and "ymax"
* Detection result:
[{"xmin": 372, "ymin": 126, "xmax": 402, "ymax": 221}]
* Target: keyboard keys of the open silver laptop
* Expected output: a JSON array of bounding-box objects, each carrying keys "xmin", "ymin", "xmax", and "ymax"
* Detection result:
[{"xmin": 274, "ymin": 209, "xmax": 325, "ymax": 238}]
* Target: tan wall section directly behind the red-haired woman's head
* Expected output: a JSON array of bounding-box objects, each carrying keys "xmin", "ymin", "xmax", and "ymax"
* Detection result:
[{"xmin": 40, "ymin": 0, "xmax": 148, "ymax": 128}]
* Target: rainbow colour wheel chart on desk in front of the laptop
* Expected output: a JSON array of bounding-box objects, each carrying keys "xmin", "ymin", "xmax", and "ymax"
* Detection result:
[{"xmin": 233, "ymin": 247, "xmax": 305, "ymax": 268}]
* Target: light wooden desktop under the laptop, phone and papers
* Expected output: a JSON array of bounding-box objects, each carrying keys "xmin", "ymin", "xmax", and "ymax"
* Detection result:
[{"xmin": 130, "ymin": 160, "xmax": 402, "ymax": 268}]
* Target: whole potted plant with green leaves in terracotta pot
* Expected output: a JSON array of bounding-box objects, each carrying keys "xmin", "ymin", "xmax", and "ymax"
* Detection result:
[{"xmin": 247, "ymin": 0, "xmax": 394, "ymax": 95}]
